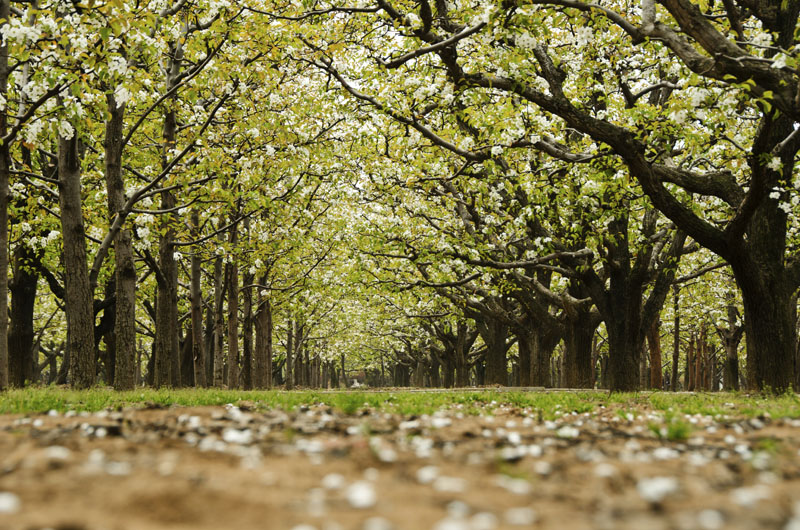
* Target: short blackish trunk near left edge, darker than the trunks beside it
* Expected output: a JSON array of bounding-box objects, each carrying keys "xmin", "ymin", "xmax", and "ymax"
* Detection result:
[{"xmin": 8, "ymin": 243, "xmax": 40, "ymax": 387}]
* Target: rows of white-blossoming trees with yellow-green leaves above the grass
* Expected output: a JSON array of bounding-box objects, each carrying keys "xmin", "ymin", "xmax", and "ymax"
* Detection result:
[{"xmin": 0, "ymin": 0, "xmax": 800, "ymax": 390}]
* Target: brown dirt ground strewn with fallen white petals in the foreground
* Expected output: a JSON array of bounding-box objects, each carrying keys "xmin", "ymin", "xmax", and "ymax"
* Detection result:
[{"xmin": 0, "ymin": 394, "xmax": 800, "ymax": 530}]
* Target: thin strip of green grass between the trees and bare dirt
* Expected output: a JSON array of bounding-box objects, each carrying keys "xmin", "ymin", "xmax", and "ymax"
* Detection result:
[{"xmin": 0, "ymin": 387, "xmax": 800, "ymax": 416}]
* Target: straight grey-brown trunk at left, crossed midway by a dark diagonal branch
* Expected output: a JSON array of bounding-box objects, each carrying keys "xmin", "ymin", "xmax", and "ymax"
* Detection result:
[{"xmin": 104, "ymin": 94, "xmax": 136, "ymax": 390}]
